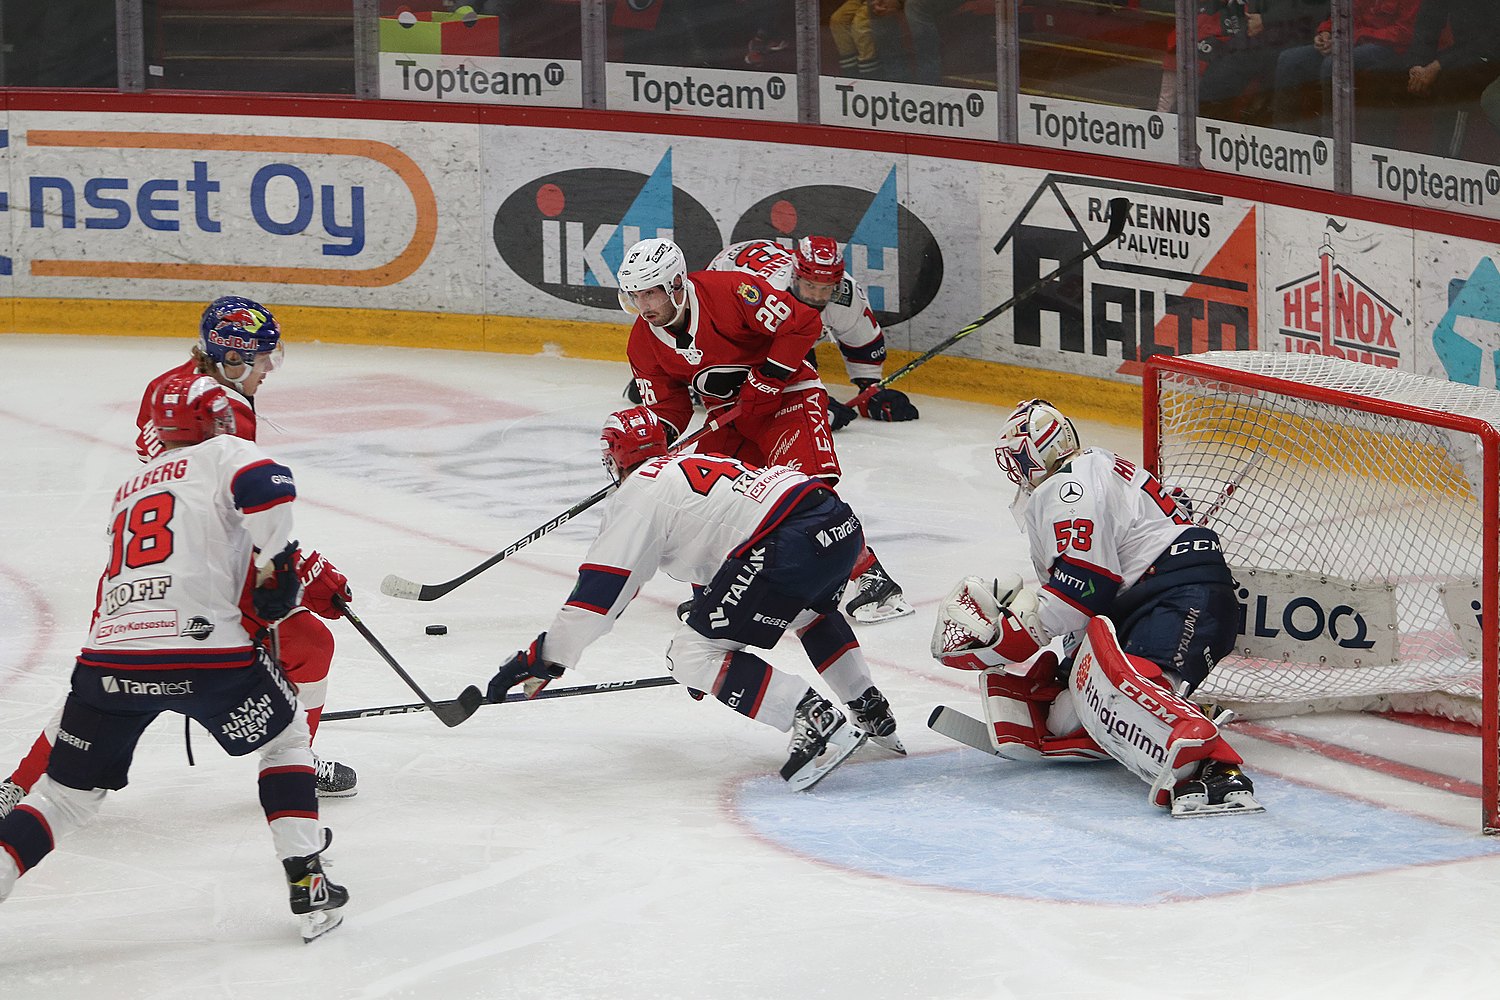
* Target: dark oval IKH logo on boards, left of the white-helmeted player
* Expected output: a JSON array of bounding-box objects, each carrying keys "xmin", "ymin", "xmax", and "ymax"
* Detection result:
[{"xmin": 494, "ymin": 148, "xmax": 720, "ymax": 313}]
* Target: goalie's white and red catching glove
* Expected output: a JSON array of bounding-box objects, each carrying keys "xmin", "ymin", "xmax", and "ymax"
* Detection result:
[{"xmin": 932, "ymin": 573, "xmax": 1050, "ymax": 670}]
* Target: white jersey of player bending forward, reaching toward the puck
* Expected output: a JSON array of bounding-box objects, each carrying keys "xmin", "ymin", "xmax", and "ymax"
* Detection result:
[{"xmin": 543, "ymin": 454, "xmax": 827, "ymax": 667}]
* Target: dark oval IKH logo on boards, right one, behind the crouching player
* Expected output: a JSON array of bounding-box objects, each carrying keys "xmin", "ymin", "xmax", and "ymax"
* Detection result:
[{"xmin": 729, "ymin": 166, "xmax": 944, "ymax": 325}]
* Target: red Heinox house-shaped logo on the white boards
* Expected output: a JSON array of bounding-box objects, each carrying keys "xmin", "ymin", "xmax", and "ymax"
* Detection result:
[{"xmin": 1277, "ymin": 219, "xmax": 1403, "ymax": 367}]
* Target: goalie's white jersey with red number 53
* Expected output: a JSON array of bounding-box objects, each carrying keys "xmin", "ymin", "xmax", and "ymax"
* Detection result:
[{"xmin": 1013, "ymin": 448, "xmax": 1193, "ymax": 636}]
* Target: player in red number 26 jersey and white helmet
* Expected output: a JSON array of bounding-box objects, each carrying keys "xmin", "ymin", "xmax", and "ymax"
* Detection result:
[{"xmin": 620, "ymin": 240, "xmax": 912, "ymax": 622}]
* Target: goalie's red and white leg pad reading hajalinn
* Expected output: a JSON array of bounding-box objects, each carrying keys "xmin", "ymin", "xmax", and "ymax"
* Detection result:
[{"xmin": 1068, "ymin": 616, "xmax": 1242, "ymax": 807}]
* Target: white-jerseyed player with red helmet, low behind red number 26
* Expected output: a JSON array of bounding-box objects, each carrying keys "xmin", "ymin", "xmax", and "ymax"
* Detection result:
[{"xmin": 708, "ymin": 235, "xmax": 920, "ymax": 430}]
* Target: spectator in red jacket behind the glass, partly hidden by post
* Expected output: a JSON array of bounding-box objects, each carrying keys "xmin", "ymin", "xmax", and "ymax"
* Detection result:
[{"xmin": 1272, "ymin": 0, "xmax": 1418, "ymax": 145}]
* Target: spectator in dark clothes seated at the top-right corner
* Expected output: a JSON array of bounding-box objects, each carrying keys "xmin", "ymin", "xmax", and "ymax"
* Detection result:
[{"xmin": 1406, "ymin": 0, "xmax": 1500, "ymax": 152}]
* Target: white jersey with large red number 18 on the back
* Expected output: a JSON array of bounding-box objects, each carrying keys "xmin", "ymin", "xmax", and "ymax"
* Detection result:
[{"xmin": 80, "ymin": 435, "xmax": 297, "ymax": 656}]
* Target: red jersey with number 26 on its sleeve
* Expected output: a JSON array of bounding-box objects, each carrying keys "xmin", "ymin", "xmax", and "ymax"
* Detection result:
[{"xmin": 626, "ymin": 271, "xmax": 824, "ymax": 433}]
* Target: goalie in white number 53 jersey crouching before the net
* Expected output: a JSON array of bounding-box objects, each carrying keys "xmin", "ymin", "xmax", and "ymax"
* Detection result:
[{"xmin": 932, "ymin": 399, "xmax": 1262, "ymax": 817}]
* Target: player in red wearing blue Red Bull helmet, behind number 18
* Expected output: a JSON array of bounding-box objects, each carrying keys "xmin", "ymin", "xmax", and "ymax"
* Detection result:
[{"xmin": 0, "ymin": 295, "xmax": 359, "ymax": 816}]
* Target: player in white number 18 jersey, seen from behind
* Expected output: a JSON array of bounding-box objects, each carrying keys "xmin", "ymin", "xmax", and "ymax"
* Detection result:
[{"xmin": 0, "ymin": 373, "xmax": 350, "ymax": 942}]
